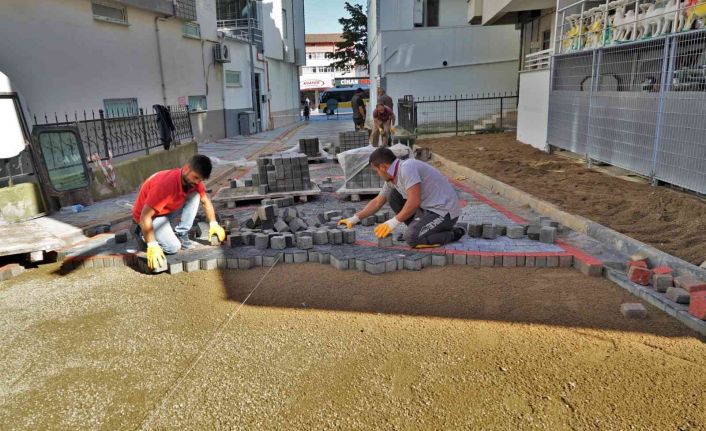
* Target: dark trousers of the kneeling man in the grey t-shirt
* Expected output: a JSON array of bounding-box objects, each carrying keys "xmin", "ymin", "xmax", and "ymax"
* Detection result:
[{"xmin": 387, "ymin": 190, "xmax": 458, "ymax": 247}]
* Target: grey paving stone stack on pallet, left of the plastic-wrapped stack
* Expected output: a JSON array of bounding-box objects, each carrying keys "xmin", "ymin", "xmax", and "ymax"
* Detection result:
[{"xmin": 236, "ymin": 153, "xmax": 311, "ymax": 195}]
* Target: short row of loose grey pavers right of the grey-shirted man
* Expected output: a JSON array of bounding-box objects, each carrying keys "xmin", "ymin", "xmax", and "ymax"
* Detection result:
[{"xmin": 458, "ymin": 217, "xmax": 560, "ymax": 244}]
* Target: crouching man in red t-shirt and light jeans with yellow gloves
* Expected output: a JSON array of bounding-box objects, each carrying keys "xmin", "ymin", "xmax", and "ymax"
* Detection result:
[{"xmin": 132, "ymin": 154, "xmax": 226, "ymax": 269}]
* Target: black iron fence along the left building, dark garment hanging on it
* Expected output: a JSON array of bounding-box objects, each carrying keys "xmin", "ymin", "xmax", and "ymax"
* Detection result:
[{"xmin": 34, "ymin": 106, "xmax": 193, "ymax": 160}]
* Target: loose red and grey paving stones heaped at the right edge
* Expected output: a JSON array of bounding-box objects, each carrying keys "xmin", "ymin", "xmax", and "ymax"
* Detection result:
[{"xmin": 626, "ymin": 255, "xmax": 706, "ymax": 320}]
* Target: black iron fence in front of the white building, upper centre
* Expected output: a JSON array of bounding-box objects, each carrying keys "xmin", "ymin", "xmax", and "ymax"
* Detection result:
[{"xmin": 397, "ymin": 93, "xmax": 517, "ymax": 134}]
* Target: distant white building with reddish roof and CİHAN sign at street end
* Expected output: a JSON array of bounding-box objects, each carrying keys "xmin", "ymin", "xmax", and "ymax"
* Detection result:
[{"xmin": 299, "ymin": 33, "xmax": 368, "ymax": 108}]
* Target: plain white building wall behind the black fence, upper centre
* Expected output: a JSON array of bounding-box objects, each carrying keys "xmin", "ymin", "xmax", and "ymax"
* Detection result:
[{"xmin": 368, "ymin": 0, "xmax": 519, "ymax": 111}]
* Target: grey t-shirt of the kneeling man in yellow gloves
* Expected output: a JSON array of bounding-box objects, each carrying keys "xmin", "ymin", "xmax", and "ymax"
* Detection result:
[{"xmin": 380, "ymin": 159, "xmax": 461, "ymax": 219}]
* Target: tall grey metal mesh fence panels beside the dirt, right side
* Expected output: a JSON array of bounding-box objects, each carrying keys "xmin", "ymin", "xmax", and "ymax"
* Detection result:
[{"xmin": 547, "ymin": 27, "xmax": 706, "ymax": 193}]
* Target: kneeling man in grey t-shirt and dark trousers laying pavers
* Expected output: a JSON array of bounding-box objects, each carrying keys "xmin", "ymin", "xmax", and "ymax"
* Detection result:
[{"xmin": 339, "ymin": 147, "xmax": 466, "ymax": 248}]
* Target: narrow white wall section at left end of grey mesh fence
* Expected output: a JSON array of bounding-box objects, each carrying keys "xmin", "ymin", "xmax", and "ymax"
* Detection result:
[{"xmin": 517, "ymin": 69, "xmax": 549, "ymax": 150}]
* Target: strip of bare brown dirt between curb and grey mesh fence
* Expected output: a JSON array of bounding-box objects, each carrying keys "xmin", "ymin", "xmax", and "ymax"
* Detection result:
[{"xmin": 418, "ymin": 134, "xmax": 706, "ymax": 265}]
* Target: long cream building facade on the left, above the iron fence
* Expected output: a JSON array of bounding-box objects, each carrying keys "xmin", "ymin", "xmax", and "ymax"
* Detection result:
[{"xmin": 0, "ymin": 0, "xmax": 304, "ymax": 142}]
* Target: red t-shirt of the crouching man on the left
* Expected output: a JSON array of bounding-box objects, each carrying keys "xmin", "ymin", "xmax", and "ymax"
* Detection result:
[{"xmin": 132, "ymin": 168, "xmax": 206, "ymax": 223}]
